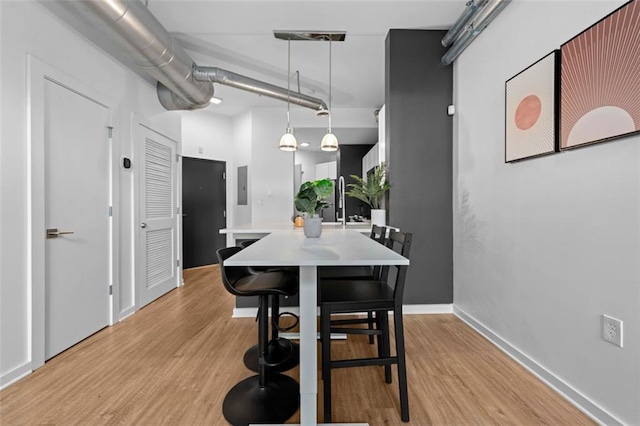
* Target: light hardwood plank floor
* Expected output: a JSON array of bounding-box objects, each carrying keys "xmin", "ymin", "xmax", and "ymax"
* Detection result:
[{"xmin": 0, "ymin": 266, "xmax": 594, "ymax": 426}]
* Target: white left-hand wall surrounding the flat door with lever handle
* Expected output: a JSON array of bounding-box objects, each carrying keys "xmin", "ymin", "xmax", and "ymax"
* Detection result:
[{"xmin": 0, "ymin": 1, "xmax": 180, "ymax": 386}]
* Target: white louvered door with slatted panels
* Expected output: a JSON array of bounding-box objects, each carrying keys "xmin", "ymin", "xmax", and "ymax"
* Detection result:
[{"xmin": 137, "ymin": 125, "xmax": 178, "ymax": 308}]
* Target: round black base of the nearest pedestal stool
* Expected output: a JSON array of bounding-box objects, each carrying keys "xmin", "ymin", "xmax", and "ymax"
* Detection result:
[{"xmin": 222, "ymin": 374, "xmax": 300, "ymax": 426}]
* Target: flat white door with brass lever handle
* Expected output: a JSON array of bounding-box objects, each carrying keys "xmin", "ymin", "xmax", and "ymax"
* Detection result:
[{"xmin": 44, "ymin": 80, "xmax": 112, "ymax": 359}]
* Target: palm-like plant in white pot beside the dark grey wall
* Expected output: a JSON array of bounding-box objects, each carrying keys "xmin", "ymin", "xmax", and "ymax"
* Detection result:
[{"xmin": 346, "ymin": 163, "xmax": 391, "ymax": 226}]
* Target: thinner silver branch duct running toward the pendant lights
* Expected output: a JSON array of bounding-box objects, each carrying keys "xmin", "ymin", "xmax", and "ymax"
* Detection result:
[{"xmin": 193, "ymin": 66, "xmax": 328, "ymax": 113}]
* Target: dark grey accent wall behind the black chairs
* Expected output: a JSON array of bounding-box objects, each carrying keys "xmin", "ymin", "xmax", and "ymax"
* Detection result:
[{"xmin": 385, "ymin": 30, "xmax": 453, "ymax": 304}]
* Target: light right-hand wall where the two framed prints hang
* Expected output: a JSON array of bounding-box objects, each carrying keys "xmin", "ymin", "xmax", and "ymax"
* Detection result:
[{"xmin": 454, "ymin": 1, "xmax": 640, "ymax": 424}]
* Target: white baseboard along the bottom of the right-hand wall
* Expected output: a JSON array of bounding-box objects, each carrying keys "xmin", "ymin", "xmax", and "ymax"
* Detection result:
[{"xmin": 453, "ymin": 305, "xmax": 624, "ymax": 426}]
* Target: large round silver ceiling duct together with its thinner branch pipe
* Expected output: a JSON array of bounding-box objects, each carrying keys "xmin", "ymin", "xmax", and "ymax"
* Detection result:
[{"xmin": 60, "ymin": 0, "xmax": 326, "ymax": 111}]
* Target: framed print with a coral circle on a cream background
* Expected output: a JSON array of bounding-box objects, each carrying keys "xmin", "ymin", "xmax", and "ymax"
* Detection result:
[{"xmin": 504, "ymin": 50, "xmax": 560, "ymax": 163}]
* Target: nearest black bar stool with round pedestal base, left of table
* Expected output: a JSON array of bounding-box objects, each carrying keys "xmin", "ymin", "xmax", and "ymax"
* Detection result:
[{"xmin": 217, "ymin": 247, "xmax": 300, "ymax": 426}]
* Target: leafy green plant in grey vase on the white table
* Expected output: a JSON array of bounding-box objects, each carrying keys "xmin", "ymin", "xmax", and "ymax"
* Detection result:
[{"xmin": 295, "ymin": 179, "xmax": 333, "ymax": 238}]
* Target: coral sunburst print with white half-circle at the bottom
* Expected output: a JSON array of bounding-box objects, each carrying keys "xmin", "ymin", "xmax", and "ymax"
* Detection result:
[{"xmin": 560, "ymin": 0, "xmax": 640, "ymax": 149}]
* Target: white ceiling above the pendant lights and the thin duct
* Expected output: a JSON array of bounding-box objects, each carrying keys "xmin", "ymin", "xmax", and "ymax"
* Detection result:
[{"xmin": 147, "ymin": 0, "xmax": 466, "ymax": 117}]
